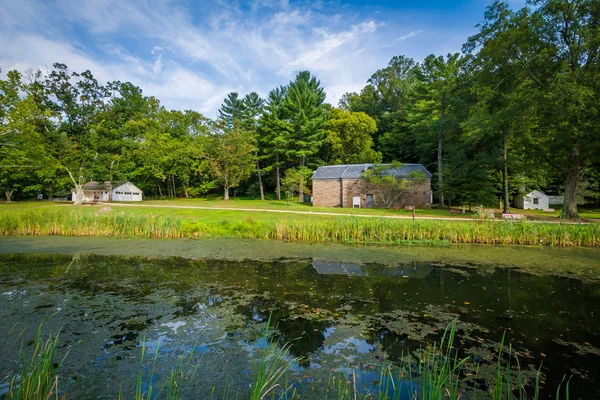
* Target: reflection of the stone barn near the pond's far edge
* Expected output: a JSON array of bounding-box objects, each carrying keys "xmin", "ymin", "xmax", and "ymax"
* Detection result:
[{"xmin": 312, "ymin": 258, "xmax": 434, "ymax": 279}]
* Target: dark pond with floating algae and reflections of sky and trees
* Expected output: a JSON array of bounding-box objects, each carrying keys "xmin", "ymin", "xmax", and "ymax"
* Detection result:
[{"xmin": 0, "ymin": 239, "xmax": 600, "ymax": 399}]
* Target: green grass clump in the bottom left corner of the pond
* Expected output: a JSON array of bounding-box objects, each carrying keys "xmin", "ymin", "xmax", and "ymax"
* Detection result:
[{"xmin": 8, "ymin": 325, "xmax": 66, "ymax": 400}]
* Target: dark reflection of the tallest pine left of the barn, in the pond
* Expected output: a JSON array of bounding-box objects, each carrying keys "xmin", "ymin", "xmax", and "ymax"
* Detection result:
[{"xmin": 238, "ymin": 296, "xmax": 331, "ymax": 366}]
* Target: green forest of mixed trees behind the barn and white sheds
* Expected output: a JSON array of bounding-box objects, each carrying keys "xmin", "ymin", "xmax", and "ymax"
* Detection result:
[{"xmin": 0, "ymin": 0, "xmax": 600, "ymax": 217}]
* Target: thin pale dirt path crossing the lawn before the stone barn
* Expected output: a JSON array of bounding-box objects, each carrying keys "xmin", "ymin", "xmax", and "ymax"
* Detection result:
[{"xmin": 98, "ymin": 203, "xmax": 584, "ymax": 224}]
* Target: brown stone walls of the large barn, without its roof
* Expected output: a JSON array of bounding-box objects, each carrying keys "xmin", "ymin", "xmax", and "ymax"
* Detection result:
[{"xmin": 313, "ymin": 179, "xmax": 431, "ymax": 208}]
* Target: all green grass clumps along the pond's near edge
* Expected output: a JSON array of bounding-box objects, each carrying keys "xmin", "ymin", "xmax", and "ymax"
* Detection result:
[{"xmin": 7, "ymin": 319, "xmax": 570, "ymax": 400}]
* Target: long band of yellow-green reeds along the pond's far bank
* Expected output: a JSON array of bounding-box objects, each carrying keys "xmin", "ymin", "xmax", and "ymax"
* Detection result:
[{"xmin": 0, "ymin": 208, "xmax": 600, "ymax": 246}]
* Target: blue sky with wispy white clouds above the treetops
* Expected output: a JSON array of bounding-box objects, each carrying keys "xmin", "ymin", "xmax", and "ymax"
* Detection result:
[{"xmin": 0, "ymin": 0, "xmax": 523, "ymax": 117}]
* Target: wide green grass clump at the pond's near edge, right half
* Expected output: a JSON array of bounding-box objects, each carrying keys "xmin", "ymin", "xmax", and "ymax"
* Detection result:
[{"xmin": 325, "ymin": 323, "xmax": 570, "ymax": 400}]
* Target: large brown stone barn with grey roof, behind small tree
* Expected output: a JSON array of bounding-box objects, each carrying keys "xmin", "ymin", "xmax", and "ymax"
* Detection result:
[{"xmin": 312, "ymin": 164, "xmax": 432, "ymax": 208}]
